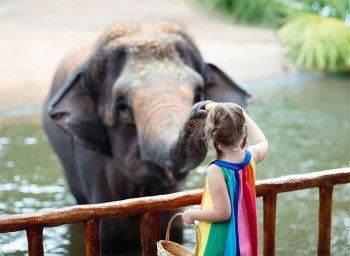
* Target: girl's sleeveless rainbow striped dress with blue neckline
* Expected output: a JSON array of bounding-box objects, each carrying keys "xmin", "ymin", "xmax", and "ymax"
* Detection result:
[{"xmin": 197, "ymin": 150, "xmax": 258, "ymax": 256}]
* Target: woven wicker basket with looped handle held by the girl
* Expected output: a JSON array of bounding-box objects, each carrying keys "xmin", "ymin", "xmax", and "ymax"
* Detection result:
[{"xmin": 157, "ymin": 213, "xmax": 197, "ymax": 256}]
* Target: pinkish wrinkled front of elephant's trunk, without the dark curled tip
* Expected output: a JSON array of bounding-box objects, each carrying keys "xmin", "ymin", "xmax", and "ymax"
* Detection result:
[{"xmin": 134, "ymin": 93, "xmax": 190, "ymax": 170}]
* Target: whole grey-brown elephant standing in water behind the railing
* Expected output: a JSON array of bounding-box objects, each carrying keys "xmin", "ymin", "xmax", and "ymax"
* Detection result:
[{"xmin": 43, "ymin": 21, "xmax": 251, "ymax": 254}]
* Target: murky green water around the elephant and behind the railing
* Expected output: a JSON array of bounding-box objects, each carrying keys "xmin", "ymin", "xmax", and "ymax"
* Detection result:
[{"xmin": 0, "ymin": 73, "xmax": 350, "ymax": 255}]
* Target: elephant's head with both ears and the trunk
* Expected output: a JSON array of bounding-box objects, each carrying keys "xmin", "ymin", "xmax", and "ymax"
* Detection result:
[{"xmin": 48, "ymin": 22, "xmax": 250, "ymax": 196}]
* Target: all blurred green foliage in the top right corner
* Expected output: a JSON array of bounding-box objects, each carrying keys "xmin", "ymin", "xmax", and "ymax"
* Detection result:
[{"xmin": 195, "ymin": 0, "xmax": 350, "ymax": 72}]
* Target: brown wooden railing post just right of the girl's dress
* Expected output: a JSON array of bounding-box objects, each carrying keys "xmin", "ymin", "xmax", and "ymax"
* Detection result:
[{"xmin": 263, "ymin": 193, "xmax": 277, "ymax": 256}]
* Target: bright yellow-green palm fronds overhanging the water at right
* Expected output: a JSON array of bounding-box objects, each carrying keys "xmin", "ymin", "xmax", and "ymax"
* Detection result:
[{"xmin": 277, "ymin": 13, "xmax": 350, "ymax": 72}]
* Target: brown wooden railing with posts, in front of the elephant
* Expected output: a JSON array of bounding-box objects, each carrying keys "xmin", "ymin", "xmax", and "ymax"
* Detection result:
[{"xmin": 0, "ymin": 168, "xmax": 350, "ymax": 256}]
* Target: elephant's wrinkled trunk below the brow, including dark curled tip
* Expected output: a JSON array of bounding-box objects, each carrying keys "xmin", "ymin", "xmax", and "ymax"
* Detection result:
[{"xmin": 134, "ymin": 91, "xmax": 207, "ymax": 184}]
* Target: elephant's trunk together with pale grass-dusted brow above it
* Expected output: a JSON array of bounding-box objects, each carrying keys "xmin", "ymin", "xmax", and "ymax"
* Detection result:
[{"xmin": 132, "ymin": 64, "xmax": 207, "ymax": 181}]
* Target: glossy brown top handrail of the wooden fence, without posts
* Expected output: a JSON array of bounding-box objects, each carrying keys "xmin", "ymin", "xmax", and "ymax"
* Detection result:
[{"xmin": 0, "ymin": 168, "xmax": 350, "ymax": 233}]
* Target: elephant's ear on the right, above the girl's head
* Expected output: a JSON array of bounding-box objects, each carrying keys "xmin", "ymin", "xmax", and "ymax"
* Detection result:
[{"xmin": 204, "ymin": 63, "xmax": 251, "ymax": 108}]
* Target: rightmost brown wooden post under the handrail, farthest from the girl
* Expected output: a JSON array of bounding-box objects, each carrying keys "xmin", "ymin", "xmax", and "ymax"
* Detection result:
[{"xmin": 317, "ymin": 184, "xmax": 333, "ymax": 256}]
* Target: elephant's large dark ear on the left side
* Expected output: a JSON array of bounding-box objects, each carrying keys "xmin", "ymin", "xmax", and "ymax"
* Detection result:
[{"xmin": 48, "ymin": 68, "xmax": 112, "ymax": 156}]
